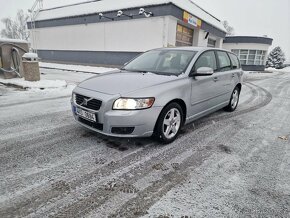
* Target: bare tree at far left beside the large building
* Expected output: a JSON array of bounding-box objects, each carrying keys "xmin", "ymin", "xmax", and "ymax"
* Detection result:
[{"xmin": 1, "ymin": 10, "xmax": 29, "ymax": 40}]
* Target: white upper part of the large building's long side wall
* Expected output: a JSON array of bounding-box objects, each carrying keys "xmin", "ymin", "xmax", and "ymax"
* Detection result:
[{"xmin": 32, "ymin": 17, "xmax": 169, "ymax": 52}]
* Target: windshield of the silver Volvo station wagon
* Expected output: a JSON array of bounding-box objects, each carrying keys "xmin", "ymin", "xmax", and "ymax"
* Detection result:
[{"xmin": 122, "ymin": 50, "xmax": 197, "ymax": 75}]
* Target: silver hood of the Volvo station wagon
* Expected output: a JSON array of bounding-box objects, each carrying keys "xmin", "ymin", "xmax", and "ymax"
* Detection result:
[{"xmin": 79, "ymin": 71, "xmax": 177, "ymax": 95}]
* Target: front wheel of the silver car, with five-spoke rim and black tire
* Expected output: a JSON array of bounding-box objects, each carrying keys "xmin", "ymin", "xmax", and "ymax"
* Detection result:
[{"xmin": 154, "ymin": 102, "xmax": 184, "ymax": 144}]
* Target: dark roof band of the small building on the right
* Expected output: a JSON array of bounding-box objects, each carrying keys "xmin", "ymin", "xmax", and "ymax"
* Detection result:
[{"xmin": 224, "ymin": 36, "xmax": 273, "ymax": 45}]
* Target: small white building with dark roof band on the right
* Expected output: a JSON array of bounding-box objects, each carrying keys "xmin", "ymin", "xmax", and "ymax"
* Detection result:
[{"xmin": 223, "ymin": 36, "xmax": 273, "ymax": 71}]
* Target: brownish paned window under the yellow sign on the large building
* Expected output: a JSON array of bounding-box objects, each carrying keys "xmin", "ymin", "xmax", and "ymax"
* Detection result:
[{"xmin": 176, "ymin": 24, "xmax": 193, "ymax": 46}]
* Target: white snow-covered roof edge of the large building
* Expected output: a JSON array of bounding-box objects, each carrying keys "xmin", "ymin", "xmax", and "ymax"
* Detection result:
[{"xmin": 36, "ymin": 0, "xmax": 226, "ymax": 32}]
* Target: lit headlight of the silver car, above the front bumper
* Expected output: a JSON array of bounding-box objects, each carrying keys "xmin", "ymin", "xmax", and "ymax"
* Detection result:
[{"xmin": 113, "ymin": 98, "xmax": 155, "ymax": 110}]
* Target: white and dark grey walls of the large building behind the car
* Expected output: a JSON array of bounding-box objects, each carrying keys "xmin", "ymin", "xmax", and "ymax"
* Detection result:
[{"xmin": 30, "ymin": 15, "xmax": 222, "ymax": 65}]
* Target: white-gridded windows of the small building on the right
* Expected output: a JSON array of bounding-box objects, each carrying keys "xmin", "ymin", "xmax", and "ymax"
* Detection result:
[{"xmin": 232, "ymin": 49, "xmax": 267, "ymax": 65}]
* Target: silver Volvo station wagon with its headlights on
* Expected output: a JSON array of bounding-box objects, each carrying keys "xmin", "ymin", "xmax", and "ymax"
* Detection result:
[{"xmin": 71, "ymin": 47, "xmax": 243, "ymax": 143}]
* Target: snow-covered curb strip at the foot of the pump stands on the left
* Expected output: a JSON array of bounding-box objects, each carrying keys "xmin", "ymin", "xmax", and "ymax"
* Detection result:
[{"xmin": 0, "ymin": 78, "xmax": 67, "ymax": 89}]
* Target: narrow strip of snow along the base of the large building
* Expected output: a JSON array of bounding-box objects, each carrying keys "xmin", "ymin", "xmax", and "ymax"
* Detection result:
[{"xmin": 39, "ymin": 62, "xmax": 116, "ymax": 74}]
